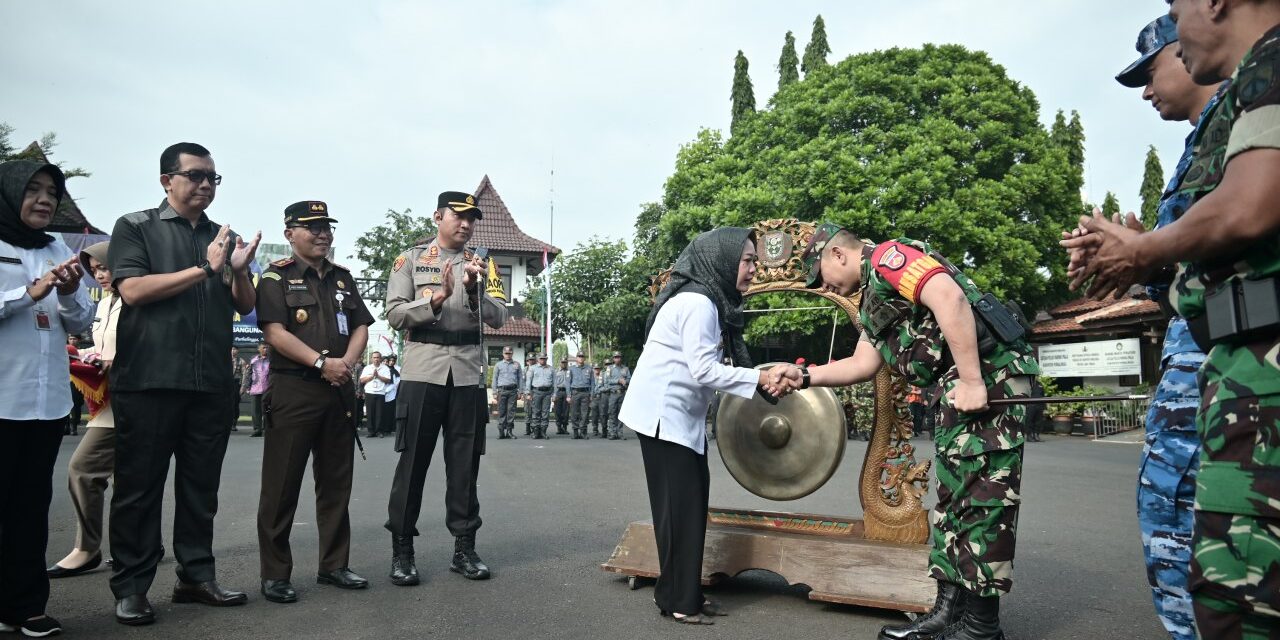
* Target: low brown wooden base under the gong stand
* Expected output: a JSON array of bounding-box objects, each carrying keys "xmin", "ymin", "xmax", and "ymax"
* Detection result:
[{"xmin": 600, "ymin": 508, "xmax": 937, "ymax": 613}]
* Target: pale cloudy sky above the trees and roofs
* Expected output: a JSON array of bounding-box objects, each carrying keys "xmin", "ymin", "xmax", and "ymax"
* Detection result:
[{"xmin": 0, "ymin": 0, "xmax": 1190, "ymax": 272}]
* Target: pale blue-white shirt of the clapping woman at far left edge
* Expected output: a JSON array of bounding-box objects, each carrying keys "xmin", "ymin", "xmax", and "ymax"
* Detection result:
[{"xmin": 0, "ymin": 239, "xmax": 93, "ymax": 420}]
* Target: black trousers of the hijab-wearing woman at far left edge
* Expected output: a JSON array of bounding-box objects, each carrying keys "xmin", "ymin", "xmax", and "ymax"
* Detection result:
[{"xmin": 0, "ymin": 419, "xmax": 67, "ymax": 626}]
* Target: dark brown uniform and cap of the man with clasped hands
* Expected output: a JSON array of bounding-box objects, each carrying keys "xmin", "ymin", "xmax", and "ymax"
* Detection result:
[{"xmin": 249, "ymin": 202, "xmax": 374, "ymax": 580}]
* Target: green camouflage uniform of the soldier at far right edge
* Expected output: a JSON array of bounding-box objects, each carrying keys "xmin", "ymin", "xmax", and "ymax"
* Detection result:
[{"xmin": 1170, "ymin": 26, "xmax": 1280, "ymax": 639}]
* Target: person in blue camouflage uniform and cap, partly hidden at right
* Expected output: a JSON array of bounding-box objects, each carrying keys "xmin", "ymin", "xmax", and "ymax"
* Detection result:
[{"xmin": 1116, "ymin": 15, "xmax": 1217, "ymax": 640}]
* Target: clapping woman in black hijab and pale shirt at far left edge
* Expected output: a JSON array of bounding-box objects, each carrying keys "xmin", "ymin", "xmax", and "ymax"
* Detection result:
[{"xmin": 0, "ymin": 160, "xmax": 93, "ymax": 636}]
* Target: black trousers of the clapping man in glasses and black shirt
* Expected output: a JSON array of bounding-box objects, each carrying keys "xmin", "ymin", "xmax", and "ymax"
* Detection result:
[{"xmin": 110, "ymin": 389, "xmax": 230, "ymax": 599}]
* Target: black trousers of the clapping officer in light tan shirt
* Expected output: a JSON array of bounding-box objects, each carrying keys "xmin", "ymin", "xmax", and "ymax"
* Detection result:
[{"xmin": 387, "ymin": 378, "xmax": 489, "ymax": 536}]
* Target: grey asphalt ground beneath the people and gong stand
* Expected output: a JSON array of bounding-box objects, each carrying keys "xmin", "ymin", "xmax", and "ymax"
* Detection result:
[{"xmin": 47, "ymin": 424, "xmax": 1167, "ymax": 640}]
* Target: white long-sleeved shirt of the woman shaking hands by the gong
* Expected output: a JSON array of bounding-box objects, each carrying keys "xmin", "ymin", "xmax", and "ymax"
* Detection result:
[{"xmin": 618, "ymin": 293, "xmax": 760, "ymax": 454}]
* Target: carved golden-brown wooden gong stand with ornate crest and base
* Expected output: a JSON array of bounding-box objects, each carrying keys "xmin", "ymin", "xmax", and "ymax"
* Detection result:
[{"xmin": 600, "ymin": 219, "xmax": 936, "ymax": 612}]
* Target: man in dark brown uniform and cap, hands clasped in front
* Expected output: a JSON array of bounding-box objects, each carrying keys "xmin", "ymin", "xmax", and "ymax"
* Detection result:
[{"xmin": 249, "ymin": 200, "xmax": 374, "ymax": 603}]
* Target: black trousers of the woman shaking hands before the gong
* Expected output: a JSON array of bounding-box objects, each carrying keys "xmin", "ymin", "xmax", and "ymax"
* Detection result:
[{"xmin": 640, "ymin": 426, "xmax": 710, "ymax": 616}]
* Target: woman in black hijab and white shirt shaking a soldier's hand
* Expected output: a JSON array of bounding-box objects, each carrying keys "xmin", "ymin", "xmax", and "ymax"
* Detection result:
[{"xmin": 618, "ymin": 228, "xmax": 769, "ymax": 625}]
